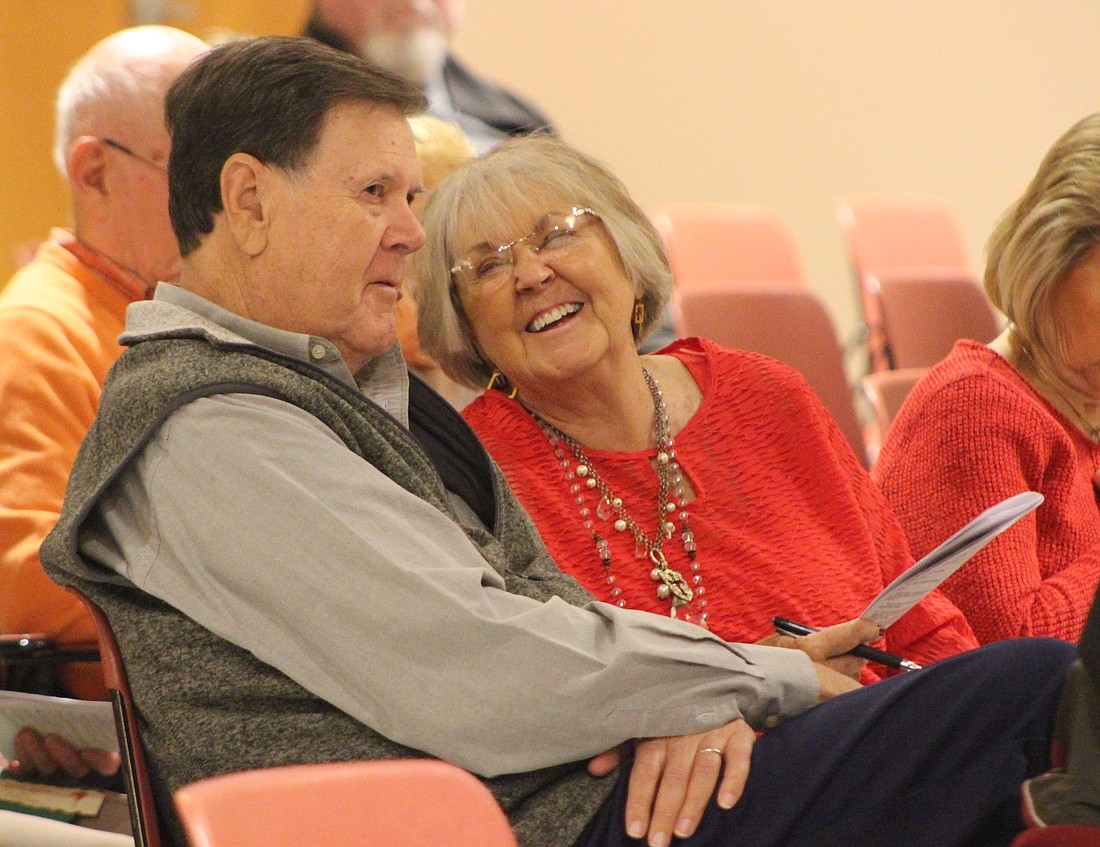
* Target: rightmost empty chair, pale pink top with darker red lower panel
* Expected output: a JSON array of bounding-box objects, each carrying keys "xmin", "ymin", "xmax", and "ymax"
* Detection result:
[{"xmin": 836, "ymin": 194, "xmax": 1000, "ymax": 371}]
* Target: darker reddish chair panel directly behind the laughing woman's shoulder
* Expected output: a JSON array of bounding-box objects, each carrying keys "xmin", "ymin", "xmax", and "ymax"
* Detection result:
[{"xmin": 681, "ymin": 283, "xmax": 868, "ymax": 466}]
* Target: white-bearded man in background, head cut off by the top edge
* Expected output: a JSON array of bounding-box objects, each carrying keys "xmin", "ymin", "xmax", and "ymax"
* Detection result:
[{"xmin": 305, "ymin": 0, "xmax": 551, "ymax": 153}]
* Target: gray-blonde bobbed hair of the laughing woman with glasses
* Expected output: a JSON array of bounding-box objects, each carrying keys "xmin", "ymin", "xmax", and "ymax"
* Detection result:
[{"xmin": 411, "ymin": 135, "xmax": 672, "ymax": 388}]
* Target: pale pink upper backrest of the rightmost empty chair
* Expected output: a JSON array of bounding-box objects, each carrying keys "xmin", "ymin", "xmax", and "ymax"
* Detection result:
[{"xmin": 836, "ymin": 194, "xmax": 992, "ymax": 371}]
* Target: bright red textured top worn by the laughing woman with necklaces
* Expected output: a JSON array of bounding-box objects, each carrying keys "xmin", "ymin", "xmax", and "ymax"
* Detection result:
[{"xmin": 463, "ymin": 339, "xmax": 977, "ymax": 681}]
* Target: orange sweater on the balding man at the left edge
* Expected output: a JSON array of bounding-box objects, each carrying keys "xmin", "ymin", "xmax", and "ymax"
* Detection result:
[{"xmin": 0, "ymin": 230, "xmax": 145, "ymax": 696}]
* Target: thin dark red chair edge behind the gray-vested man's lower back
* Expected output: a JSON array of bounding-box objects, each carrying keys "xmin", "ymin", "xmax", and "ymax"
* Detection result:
[{"xmin": 72, "ymin": 589, "xmax": 161, "ymax": 847}]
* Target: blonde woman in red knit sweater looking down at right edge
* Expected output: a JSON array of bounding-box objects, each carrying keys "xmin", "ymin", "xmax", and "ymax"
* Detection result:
[{"xmin": 873, "ymin": 114, "xmax": 1100, "ymax": 642}]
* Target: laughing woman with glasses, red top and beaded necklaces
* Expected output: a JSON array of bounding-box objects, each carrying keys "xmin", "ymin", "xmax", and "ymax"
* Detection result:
[{"xmin": 413, "ymin": 138, "xmax": 976, "ymax": 681}]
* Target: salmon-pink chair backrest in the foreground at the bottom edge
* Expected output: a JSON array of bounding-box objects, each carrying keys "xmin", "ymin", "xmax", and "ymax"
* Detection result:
[{"xmin": 175, "ymin": 759, "xmax": 516, "ymax": 847}]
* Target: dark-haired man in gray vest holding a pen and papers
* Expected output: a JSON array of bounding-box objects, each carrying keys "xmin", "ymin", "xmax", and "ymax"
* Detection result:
[{"xmin": 43, "ymin": 31, "xmax": 1074, "ymax": 847}]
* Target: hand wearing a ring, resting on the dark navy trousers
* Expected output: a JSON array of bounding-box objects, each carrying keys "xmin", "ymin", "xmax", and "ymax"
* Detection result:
[{"xmin": 620, "ymin": 721, "xmax": 756, "ymax": 847}]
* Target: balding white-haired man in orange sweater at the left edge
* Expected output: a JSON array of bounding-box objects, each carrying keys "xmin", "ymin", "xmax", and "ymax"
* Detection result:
[{"xmin": 0, "ymin": 26, "xmax": 206, "ymax": 773}]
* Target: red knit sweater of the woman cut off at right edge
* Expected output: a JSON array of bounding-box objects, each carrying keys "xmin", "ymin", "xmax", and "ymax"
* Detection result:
[{"xmin": 875, "ymin": 341, "xmax": 1100, "ymax": 642}]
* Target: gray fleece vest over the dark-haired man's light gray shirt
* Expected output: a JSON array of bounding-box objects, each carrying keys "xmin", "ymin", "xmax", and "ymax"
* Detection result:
[{"xmin": 42, "ymin": 331, "xmax": 614, "ymax": 847}]
